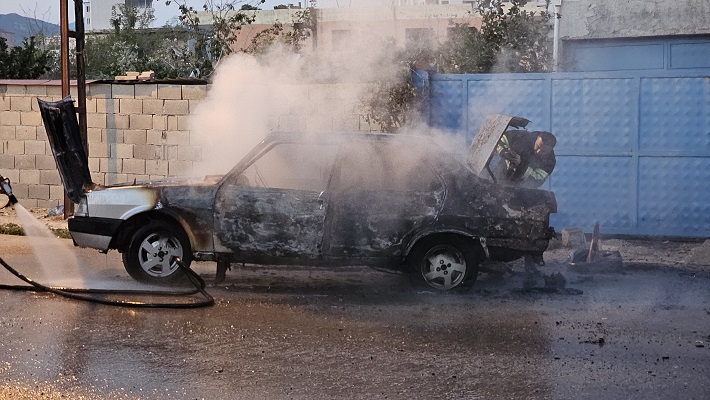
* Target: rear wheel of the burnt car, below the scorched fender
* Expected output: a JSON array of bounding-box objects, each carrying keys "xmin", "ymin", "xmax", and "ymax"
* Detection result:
[{"xmin": 407, "ymin": 235, "xmax": 479, "ymax": 292}]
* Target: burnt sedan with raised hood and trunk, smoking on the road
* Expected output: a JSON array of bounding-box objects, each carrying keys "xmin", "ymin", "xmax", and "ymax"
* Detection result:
[{"xmin": 39, "ymin": 98, "xmax": 557, "ymax": 291}]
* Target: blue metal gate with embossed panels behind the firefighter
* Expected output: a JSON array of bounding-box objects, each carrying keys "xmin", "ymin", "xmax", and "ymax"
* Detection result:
[{"xmin": 428, "ymin": 68, "xmax": 710, "ymax": 237}]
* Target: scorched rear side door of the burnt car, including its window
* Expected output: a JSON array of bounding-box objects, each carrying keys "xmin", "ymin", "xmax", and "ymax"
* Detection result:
[{"xmin": 326, "ymin": 139, "xmax": 445, "ymax": 258}]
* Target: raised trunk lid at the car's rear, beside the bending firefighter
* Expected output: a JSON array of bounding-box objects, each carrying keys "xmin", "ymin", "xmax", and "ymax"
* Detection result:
[{"xmin": 467, "ymin": 114, "xmax": 530, "ymax": 176}]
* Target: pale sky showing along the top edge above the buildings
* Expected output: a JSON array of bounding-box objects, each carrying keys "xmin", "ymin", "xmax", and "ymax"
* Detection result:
[{"xmin": 0, "ymin": 0, "xmax": 390, "ymax": 26}]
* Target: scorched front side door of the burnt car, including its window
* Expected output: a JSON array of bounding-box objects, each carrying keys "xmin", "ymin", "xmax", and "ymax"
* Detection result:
[{"xmin": 215, "ymin": 143, "xmax": 337, "ymax": 262}]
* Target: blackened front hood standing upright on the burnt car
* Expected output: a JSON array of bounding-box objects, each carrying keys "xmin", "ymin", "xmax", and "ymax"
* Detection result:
[{"xmin": 37, "ymin": 96, "xmax": 94, "ymax": 203}]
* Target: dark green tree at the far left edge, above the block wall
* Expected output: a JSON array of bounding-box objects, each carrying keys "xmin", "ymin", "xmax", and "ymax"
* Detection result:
[{"xmin": 0, "ymin": 36, "xmax": 52, "ymax": 79}]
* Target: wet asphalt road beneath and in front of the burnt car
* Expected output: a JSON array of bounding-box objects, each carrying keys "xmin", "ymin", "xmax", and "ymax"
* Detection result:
[{"xmin": 0, "ymin": 236, "xmax": 710, "ymax": 399}]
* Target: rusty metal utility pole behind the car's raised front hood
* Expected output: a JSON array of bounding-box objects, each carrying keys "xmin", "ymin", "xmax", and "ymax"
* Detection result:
[{"xmin": 59, "ymin": 0, "xmax": 89, "ymax": 219}]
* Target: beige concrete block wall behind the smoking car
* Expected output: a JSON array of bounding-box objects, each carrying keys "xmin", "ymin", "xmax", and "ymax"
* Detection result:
[{"xmin": 0, "ymin": 81, "xmax": 374, "ymax": 208}]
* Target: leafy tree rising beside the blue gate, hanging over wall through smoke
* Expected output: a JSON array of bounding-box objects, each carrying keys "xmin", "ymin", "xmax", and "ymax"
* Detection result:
[{"xmin": 362, "ymin": 0, "xmax": 558, "ymax": 132}]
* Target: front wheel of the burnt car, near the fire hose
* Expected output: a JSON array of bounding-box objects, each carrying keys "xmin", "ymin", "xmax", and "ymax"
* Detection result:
[{"xmin": 123, "ymin": 221, "xmax": 192, "ymax": 284}]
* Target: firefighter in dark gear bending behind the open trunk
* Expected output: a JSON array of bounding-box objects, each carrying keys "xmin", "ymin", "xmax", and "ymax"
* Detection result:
[{"xmin": 496, "ymin": 130, "xmax": 557, "ymax": 188}]
